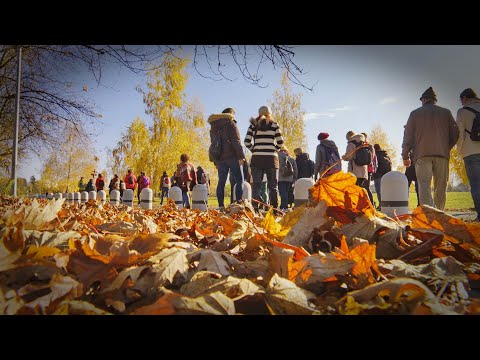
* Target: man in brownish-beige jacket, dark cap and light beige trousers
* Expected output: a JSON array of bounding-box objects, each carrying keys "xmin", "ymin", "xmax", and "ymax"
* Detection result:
[{"xmin": 402, "ymin": 87, "xmax": 458, "ymax": 210}]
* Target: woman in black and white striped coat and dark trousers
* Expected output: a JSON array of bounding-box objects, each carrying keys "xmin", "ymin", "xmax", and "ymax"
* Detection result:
[{"xmin": 244, "ymin": 106, "xmax": 283, "ymax": 210}]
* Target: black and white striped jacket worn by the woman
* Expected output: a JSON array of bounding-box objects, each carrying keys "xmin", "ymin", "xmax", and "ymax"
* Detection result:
[{"xmin": 244, "ymin": 118, "xmax": 283, "ymax": 169}]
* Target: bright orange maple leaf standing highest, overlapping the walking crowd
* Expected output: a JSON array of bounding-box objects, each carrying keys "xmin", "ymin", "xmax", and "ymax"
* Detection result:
[{"xmin": 308, "ymin": 171, "xmax": 375, "ymax": 216}]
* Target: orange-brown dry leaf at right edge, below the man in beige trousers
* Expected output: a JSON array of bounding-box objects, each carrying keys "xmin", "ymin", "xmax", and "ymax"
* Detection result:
[{"xmin": 412, "ymin": 205, "xmax": 480, "ymax": 245}]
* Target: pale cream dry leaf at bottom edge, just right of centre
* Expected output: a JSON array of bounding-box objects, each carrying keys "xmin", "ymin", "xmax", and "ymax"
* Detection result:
[{"xmin": 266, "ymin": 274, "xmax": 316, "ymax": 315}]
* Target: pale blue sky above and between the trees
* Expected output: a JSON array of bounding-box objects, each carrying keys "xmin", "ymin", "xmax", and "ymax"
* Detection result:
[{"xmin": 19, "ymin": 45, "xmax": 480, "ymax": 178}]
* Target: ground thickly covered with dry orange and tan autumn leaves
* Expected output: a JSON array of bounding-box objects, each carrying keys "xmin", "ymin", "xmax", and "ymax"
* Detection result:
[{"xmin": 0, "ymin": 173, "xmax": 480, "ymax": 315}]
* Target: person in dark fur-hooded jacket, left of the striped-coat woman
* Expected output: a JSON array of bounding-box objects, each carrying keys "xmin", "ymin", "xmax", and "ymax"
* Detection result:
[{"xmin": 208, "ymin": 108, "xmax": 245, "ymax": 209}]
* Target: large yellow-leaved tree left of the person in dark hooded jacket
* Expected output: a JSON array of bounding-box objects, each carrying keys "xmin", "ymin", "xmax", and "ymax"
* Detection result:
[{"xmin": 110, "ymin": 55, "xmax": 216, "ymax": 191}]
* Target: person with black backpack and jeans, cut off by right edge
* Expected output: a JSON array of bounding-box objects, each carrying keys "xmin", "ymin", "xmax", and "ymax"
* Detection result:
[{"xmin": 457, "ymin": 88, "xmax": 480, "ymax": 221}]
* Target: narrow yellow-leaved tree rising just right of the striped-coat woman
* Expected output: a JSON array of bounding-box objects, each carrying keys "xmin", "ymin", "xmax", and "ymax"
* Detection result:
[{"xmin": 269, "ymin": 71, "xmax": 307, "ymax": 153}]
